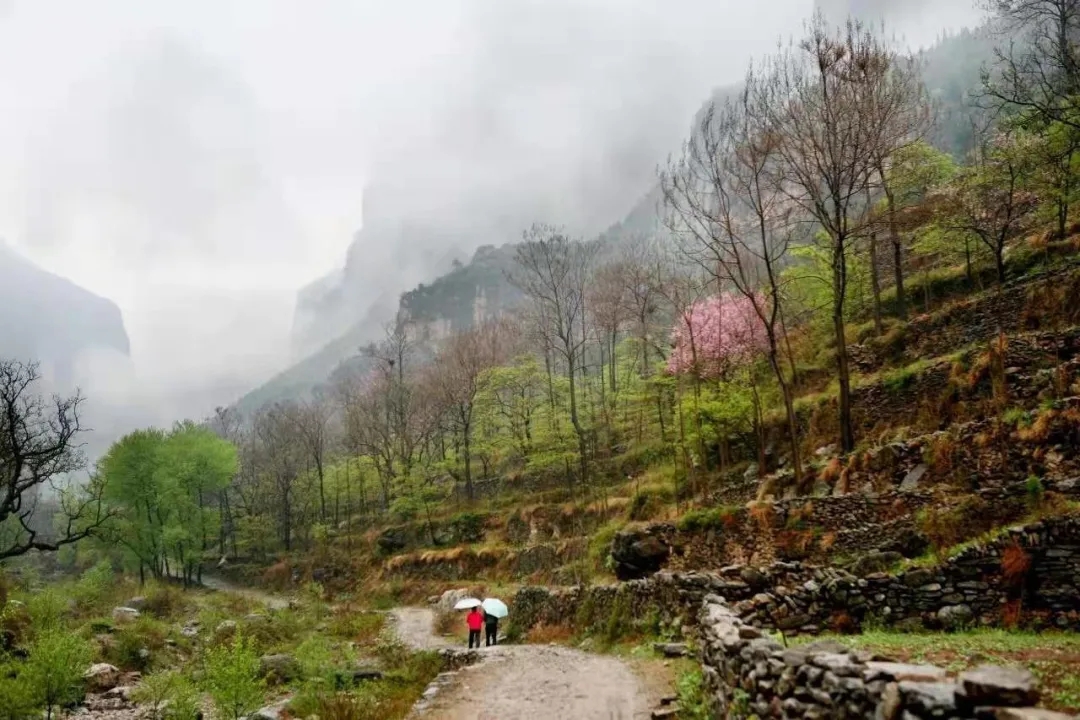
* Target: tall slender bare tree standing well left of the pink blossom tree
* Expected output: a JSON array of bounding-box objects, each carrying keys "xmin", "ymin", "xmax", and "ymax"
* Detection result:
[{"xmin": 511, "ymin": 226, "xmax": 597, "ymax": 490}]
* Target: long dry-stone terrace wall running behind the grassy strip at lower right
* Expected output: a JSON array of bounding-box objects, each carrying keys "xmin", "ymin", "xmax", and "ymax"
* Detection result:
[{"xmin": 513, "ymin": 517, "xmax": 1080, "ymax": 635}]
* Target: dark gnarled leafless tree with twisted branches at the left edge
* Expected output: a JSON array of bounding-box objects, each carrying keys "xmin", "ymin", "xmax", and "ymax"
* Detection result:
[{"xmin": 0, "ymin": 359, "xmax": 110, "ymax": 560}]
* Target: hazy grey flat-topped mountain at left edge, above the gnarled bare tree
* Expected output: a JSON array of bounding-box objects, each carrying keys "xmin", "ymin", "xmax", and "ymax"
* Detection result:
[{"xmin": 0, "ymin": 241, "xmax": 130, "ymax": 388}]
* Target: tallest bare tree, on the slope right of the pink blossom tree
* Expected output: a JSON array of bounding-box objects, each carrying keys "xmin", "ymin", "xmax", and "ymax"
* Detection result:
[{"xmin": 759, "ymin": 13, "xmax": 895, "ymax": 451}]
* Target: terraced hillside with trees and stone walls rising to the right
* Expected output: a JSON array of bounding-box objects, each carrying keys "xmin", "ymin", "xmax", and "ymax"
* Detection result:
[{"xmin": 10, "ymin": 5, "xmax": 1080, "ymax": 720}]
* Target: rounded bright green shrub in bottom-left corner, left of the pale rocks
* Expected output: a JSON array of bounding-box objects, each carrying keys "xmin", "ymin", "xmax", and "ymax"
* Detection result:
[{"xmin": 25, "ymin": 627, "xmax": 93, "ymax": 720}]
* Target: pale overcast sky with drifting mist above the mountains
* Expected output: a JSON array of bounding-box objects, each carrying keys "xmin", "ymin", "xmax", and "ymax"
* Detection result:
[{"xmin": 0, "ymin": 0, "xmax": 984, "ymax": 427}]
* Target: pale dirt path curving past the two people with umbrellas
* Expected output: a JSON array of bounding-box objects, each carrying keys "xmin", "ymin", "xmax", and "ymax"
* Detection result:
[{"xmin": 392, "ymin": 608, "xmax": 650, "ymax": 720}]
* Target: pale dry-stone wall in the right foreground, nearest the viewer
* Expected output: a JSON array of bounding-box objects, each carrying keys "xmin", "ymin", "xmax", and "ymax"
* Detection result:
[{"xmin": 699, "ymin": 595, "xmax": 1068, "ymax": 720}]
